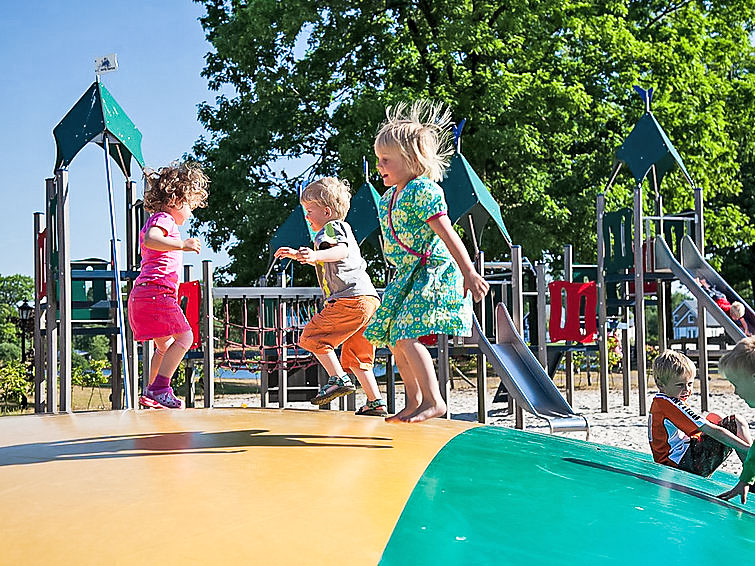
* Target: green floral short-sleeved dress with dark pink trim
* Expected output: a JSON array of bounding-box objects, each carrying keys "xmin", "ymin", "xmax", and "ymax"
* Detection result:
[{"xmin": 364, "ymin": 177, "xmax": 472, "ymax": 346}]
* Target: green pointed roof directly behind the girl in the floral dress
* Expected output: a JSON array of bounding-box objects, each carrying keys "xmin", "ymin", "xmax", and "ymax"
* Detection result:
[{"xmin": 440, "ymin": 153, "xmax": 511, "ymax": 245}]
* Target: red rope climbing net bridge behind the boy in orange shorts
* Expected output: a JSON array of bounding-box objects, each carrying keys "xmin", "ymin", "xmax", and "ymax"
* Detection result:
[{"xmin": 215, "ymin": 295, "xmax": 320, "ymax": 378}]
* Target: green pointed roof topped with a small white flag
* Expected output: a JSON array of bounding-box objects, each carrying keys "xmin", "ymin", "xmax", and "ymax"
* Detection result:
[{"xmin": 52, "ymin": 82, "xmax": 144, "ymax": 177}]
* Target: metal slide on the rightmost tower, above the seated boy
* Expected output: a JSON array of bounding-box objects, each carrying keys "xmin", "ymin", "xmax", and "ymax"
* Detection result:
[{"xmin": 655, "ymin": 236, "xmax": 755, "ymax": 342}]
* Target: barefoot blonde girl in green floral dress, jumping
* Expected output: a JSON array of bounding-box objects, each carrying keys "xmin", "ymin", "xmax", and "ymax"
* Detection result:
[{"xmin": 365, "ymin": 101, "xmax": 489, "ymax": 422}]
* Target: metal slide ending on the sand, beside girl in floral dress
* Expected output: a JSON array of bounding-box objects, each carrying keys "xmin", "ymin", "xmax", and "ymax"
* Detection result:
[{"xmin": 472, "ymin": 304, "xmax": 590, "ymax": 437}]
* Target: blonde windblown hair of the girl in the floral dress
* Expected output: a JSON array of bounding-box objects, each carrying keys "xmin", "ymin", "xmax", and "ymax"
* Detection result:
[{"xmin": 375, "ymin": 100, "xmax": 453, "ymax": 182}]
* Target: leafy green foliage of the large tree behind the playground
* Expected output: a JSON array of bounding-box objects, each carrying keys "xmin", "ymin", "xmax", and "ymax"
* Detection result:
[{"xmin": 194, "ymin": 0, "xmax": 755, "ymax": 292}]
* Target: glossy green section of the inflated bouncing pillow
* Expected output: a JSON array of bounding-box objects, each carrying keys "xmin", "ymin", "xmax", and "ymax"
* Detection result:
[{"xmin": 380, "ymin": 427, "xmax": 755, "ymax": 566}]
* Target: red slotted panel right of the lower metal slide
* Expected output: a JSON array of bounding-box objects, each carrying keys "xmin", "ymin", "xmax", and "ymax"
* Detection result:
[{"xmin": 548, "ymin": 281, "xmax": 598, "ymax": 343}]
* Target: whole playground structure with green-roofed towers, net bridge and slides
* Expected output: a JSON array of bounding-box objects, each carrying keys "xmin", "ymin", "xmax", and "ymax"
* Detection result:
[{"xmin": 28, "ymin": 81, "xmax": 755, "ymax": 431}]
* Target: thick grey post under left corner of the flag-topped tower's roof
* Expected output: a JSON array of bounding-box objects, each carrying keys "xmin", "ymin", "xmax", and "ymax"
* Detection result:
[{"xmin": 51, "ymin": 168, "xmax": 73, "ymax": 413}]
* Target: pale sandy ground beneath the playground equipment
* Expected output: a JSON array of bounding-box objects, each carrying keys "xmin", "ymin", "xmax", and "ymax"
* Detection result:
[{"xmin": 215, "ymin": 379, "xmax": 755, "ymax": 480}]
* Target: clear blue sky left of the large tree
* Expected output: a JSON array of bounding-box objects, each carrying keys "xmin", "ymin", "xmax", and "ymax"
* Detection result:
[{"xmin": 0, "ymin": 0, "xmax": 236, "ymax": 275}]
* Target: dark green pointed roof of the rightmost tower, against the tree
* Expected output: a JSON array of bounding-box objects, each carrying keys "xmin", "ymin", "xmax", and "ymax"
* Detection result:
[{"xmin": 616, "ymin": 112, "xmax": 694, "ymax": 185}]
